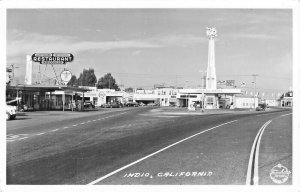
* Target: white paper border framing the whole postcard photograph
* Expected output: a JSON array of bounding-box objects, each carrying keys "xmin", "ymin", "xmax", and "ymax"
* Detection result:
[{"xmin": 0, "ymin": 0, "xmax": 300, "ymax": 192}]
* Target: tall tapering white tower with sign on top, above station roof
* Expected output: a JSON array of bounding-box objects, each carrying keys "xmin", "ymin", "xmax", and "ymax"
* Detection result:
[{"xmin": 206, "ymin": 27, "xmax": 217, "ymax": 89}]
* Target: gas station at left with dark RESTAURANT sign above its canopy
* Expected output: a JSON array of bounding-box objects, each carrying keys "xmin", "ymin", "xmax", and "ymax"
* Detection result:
[{"xmin": 6, "ymin": 53, "xmax": 88, "ymax": 111}]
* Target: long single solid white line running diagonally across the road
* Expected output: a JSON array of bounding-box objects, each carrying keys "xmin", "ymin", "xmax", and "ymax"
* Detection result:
[{"xmin": 87, "ymin": 120, "xmax": 238, "ymax": 185}]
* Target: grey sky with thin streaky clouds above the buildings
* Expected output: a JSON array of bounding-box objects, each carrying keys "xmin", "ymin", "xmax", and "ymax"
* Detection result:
[{"xmin": 7, "ymin": 9, "xmax": 293, "ymax": 92}]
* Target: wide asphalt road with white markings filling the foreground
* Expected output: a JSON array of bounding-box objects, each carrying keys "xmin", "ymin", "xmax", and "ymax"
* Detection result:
[{"xmin": 7, "ymin": 107, "xmax": 292, "ymax": 184}]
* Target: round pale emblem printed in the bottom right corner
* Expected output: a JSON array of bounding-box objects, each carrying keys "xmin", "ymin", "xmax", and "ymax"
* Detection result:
[{"xmin": 270, "ymin": 163, "xmax": 291, "ymax": 184}]
